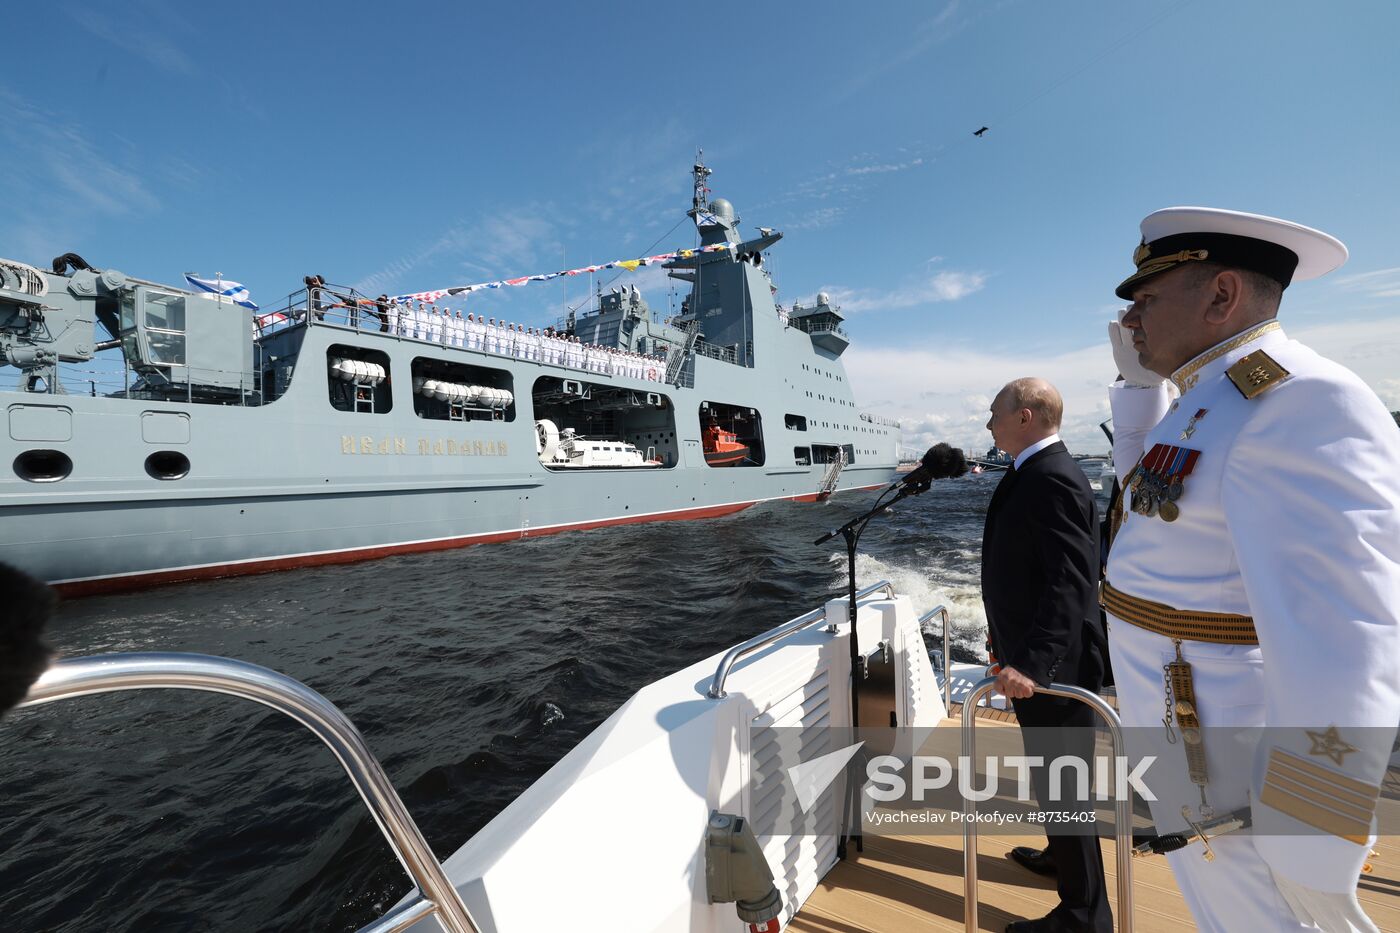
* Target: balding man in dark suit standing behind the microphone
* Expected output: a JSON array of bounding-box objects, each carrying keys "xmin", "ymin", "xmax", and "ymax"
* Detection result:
[{"xmin": 981, "ymin": 378, "xmax": 1113, "ymax": 933}]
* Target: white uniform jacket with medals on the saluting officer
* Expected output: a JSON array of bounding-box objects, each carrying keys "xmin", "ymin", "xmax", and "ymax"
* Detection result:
[{"xmin": 1107, "ymin": 322, "xmax": 1400, "ymax": 891}]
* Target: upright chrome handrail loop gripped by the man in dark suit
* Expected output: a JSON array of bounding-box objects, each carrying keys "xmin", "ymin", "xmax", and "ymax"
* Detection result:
[{"xmin": 962, "ymin": 677, "xmax": 1133, "ymax": 933}]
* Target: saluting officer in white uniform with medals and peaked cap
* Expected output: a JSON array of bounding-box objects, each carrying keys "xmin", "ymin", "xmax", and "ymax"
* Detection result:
[{"xmin": 1103, "ymin": 207, "xmax": 1400, "ymax": 930}]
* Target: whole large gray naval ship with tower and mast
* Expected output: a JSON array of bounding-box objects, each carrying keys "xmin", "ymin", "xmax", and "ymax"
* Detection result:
[{"xmin": 0, "ymin": 163, "xmax": 899, "ymax": 595}]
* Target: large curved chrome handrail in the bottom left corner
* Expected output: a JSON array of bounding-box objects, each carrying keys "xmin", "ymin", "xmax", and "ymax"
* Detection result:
[{"xmin": 10, "ymin": 651, "xmax": 480, "ymax": 933}]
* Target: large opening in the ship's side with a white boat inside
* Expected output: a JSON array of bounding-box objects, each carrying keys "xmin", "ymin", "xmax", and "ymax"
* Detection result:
[{"xmin": 531, "ymin": 375, "xmax": 680, "ymax": 472}]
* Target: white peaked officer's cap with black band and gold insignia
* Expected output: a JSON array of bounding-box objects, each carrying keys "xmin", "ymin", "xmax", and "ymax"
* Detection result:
[{"xmin": 1116, "ymin": 207, "xmax": 1347, "ymax": 301}]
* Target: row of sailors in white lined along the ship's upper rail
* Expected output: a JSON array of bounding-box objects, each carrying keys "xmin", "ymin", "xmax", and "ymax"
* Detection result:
[{"xmin": 388, "ymin": 301, "xmax": 665, "ymax": 382}]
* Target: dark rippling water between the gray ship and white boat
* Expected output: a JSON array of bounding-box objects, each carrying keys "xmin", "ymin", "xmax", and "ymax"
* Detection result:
[{"xmin": 0, "ymin": 476, "xmax": 1097, "ymax": 930}]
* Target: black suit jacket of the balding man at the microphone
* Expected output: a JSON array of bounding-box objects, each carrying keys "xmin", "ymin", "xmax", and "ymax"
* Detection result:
[{"xmin": 981, "ymin": 441, "xmax": 1107, "ymax": 692}]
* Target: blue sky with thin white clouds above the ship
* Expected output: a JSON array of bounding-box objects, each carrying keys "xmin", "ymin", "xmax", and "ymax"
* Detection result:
[{"xmin": 0, "ymin": 0, "xmax": 1400, "ymax": 450}]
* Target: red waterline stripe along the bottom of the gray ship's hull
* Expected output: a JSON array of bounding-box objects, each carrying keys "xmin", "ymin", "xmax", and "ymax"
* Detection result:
[{"xmin": 53, "ymin": 483, "xmax": 883, "ymax": 598}]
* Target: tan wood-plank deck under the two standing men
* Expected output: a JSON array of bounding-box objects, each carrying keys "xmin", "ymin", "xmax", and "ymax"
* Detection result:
[{"xmin": 787, "ymin": 716, "xmax": 1400, "ymax": 933}]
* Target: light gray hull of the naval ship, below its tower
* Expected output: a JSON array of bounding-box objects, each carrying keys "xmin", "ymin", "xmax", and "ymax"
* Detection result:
[{"xmin": 0, "ymin": 303, "xmax": 899, "ymax": 594}]
